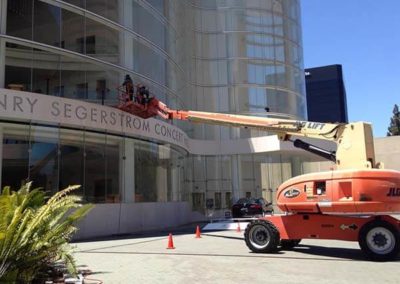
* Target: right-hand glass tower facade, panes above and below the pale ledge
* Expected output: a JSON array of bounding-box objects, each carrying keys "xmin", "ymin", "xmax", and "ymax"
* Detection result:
[{"xmin": 186, "ymin": 0, "xmax": 306, "ymax": 213}]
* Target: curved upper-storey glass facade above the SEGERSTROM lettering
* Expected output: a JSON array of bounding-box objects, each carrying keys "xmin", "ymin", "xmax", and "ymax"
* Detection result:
[{"xmin": 3, "ymin": 0, "xmax": 187, "ymax": 108}]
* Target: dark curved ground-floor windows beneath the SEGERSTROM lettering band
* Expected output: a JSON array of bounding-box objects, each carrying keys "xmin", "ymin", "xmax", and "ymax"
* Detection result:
[{"xmin": 0, "ymin": 123, "xmax": 188, "ymax": 203}]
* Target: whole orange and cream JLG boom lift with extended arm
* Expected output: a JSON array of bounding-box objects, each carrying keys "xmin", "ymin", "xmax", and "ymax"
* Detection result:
[{"xmin": 119, "ymin": 91, "xmax": 400, "ymax": 261}]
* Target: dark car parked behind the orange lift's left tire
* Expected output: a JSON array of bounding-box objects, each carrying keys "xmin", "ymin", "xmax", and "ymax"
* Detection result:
[{"xmin": 232, "ymin": 197, "xmax": 274, "ymax": 218}]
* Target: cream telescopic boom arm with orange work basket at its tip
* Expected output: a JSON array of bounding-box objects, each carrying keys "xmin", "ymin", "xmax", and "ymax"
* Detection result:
[{"xmin": 118, "ymin": 95, "xmax": 381, "ymax": 169}]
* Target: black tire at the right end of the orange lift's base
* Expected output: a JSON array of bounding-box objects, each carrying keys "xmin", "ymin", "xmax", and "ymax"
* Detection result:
[{"xmin": 358, "ymin": 220, "xmax": 400, "ymax": 261}]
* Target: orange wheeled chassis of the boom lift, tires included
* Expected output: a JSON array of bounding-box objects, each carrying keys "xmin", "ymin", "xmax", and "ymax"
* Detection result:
[{"xmin": 244, "ymin": 213, "xmax": 400, "ymax": 261}]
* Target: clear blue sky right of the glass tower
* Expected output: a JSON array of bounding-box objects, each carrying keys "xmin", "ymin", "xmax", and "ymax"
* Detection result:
[{"xmin": 300, "ymin": 0, "xmax": 400, "ymax": 137}]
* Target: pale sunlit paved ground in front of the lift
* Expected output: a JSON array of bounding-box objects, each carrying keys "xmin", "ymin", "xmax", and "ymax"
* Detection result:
[{"xmin": 75, "ymin": 224, "xmax": 400, "ymax": 284}]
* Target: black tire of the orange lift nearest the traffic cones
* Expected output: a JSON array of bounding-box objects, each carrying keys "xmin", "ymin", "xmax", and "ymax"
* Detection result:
[{"xmin": 244, "ymin": 219, "xmax": 280, "ymax": 253}]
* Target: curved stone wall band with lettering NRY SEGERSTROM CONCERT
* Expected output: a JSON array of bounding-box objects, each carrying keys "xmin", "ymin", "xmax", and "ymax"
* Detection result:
[{"xmin": 0, "ymin": 89, "xmax": 188, "ymax": 150}]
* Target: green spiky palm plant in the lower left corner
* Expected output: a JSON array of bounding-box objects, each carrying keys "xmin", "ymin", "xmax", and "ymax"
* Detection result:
[{"xmin": 0, "ymin": 183, "xmax": 93, "ymax": 283}]
